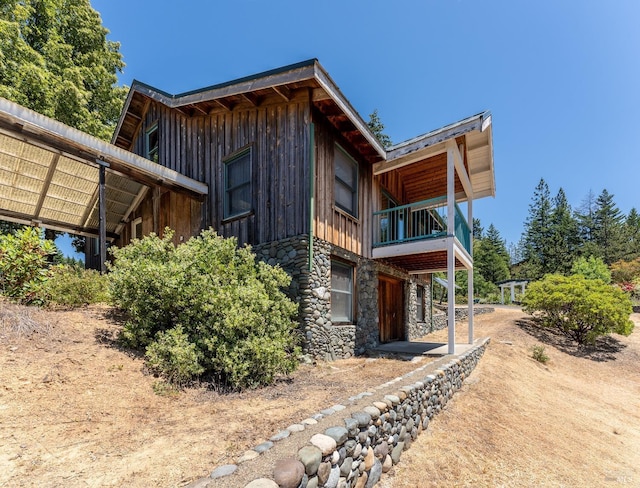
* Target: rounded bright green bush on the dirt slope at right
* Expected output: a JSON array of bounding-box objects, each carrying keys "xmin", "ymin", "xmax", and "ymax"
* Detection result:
[{"xmin": 522, "ymin": 275, "xmax": 633, "ymax": 344}]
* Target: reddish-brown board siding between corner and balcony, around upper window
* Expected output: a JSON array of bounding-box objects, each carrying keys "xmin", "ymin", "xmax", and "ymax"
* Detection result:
[{"xmin": 313, "ymin": 119, "xmax": 377, "ymax": 257}]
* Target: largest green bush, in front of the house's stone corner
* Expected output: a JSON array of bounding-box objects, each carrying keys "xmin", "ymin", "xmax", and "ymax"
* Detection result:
[{"xmin": 110, "ymin": 229, "xmax": 298, "ymax": 388}]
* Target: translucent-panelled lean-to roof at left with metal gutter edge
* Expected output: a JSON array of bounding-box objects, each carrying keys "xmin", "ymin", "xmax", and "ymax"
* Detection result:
[{"xmin": 0, "ymin": 98, "xmax": 208, "ymax": 237}]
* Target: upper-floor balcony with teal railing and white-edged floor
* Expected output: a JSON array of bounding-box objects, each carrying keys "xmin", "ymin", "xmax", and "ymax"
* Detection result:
[{"xmin": 372, "ymin": 197, "xmax": 472, "ymax": 272}]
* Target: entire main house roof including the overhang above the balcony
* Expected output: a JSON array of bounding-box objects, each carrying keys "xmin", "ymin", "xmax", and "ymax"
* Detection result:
[{"xmin": 113, "ymin": 59, "xmax": 495, "ymax": 201}]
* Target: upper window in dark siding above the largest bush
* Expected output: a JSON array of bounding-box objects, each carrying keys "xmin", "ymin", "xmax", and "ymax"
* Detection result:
[{"xmin": 224, "ymin": 149, "xmax": 251, "ymax": 219}]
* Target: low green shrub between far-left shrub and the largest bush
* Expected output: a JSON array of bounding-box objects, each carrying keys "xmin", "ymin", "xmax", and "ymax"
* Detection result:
[{"xmin": 37, "ymin": 265, "xmax": 108, "ymax": 307}]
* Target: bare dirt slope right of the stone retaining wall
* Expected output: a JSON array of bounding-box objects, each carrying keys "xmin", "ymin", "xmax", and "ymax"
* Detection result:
[{"xmin": 381, "ymin": 310, "xmax": 640, "ymax": 488}]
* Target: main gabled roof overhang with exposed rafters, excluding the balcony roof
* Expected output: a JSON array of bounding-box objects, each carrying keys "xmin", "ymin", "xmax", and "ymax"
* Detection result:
[{"xmin": 112, "ymin": 59, "xmax": 386, "ymax": 163}]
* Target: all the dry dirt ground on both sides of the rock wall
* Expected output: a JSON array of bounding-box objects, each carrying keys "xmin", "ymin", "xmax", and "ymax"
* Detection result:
[{"xmin": 0, "ymin": 303, "xmax": 640, "ymax": 488}]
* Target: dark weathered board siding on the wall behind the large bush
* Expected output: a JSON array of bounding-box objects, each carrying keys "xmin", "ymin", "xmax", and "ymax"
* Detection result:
[{"xmin": 133, "ymin": 98, "xmax": 310, "ymax": 245}]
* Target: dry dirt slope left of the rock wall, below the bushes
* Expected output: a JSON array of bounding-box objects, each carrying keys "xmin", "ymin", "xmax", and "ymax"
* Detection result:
[{"xmin": 0, "ymin": 302, "xmax": 427, "ymax": 488}]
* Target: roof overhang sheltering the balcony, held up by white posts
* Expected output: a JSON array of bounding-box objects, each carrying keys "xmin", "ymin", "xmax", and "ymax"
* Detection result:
[{"xmin": 373, "ymin": 112, "xmax": 496, "ymax": 201}]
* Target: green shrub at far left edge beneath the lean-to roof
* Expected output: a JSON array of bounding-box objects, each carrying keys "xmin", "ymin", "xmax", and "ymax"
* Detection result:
[{"xmin": 0, "ymin": 227, "xmax": 58, "ymax": 304}]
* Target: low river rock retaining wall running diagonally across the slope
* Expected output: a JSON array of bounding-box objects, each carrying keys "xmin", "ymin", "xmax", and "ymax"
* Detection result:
[{"xmin": 194, "ymin": 338, "xmax": 489, "ymax": 488}]
